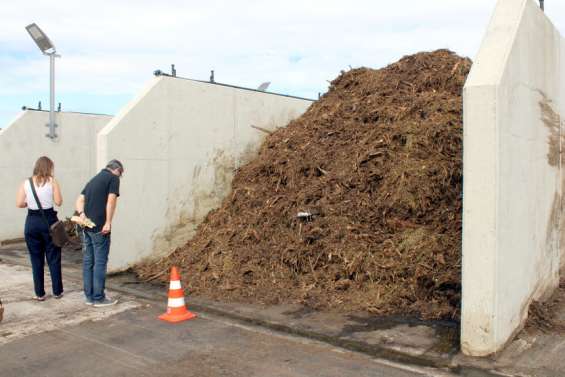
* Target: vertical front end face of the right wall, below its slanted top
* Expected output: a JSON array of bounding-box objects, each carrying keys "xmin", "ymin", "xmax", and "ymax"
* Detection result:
[{"xmin": 461, "ymin": 86, "xmax": 498, "ymax": 348}]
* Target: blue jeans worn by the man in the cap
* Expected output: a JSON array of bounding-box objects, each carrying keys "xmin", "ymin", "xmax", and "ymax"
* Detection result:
[{"xmin": 82, "ymin": 231, "xmax": 110, "ymax": 302}]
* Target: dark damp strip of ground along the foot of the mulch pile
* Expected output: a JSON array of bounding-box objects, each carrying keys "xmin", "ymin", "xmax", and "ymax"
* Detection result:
[{"xmin": 0, "ymin": 245, "xmax": 459, "ymax": 367}]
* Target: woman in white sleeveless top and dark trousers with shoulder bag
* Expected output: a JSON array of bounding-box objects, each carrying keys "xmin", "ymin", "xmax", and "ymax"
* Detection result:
[{"xmin": 16, "ymin": 156, "xmax": 63, "ymax": 301}]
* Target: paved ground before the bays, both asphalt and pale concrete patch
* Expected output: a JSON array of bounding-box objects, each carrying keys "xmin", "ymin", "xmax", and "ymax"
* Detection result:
[{"xmin": 0, "ymin": 244, "xmax": 458, "ymax": 377}]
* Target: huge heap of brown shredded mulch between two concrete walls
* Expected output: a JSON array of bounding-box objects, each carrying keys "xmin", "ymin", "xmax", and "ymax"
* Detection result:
[{"xmin": 135, "ymin": 50, "xmax": 471, "ymax": 319}]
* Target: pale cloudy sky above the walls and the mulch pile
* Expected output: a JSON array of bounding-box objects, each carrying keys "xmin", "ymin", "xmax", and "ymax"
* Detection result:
[{"xmin": 0, "ymin": 0, "xmax": 565, "ymax": 128}]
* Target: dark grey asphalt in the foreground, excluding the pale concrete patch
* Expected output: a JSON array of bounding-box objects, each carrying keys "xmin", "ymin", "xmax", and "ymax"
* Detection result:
[{"xmin": 0, "ymin": 306, "xmax": 456, "ymax": 377}]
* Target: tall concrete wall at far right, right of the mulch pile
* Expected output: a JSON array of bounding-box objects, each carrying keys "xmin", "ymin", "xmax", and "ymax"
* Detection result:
[{"xmin": 461, "ymin": 0, "xmax": 565, "ymax": 356}]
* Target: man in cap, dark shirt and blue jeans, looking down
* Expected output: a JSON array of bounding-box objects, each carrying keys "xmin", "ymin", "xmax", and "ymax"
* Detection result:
[{"xmin": 76, "ymin": 160, "xmax": 124, "ymax": 307}]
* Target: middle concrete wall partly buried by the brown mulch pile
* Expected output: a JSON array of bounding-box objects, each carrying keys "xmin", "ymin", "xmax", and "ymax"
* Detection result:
[{"xmin": 98, "ymin": 77, "xmax": 311, "ymax": 271}]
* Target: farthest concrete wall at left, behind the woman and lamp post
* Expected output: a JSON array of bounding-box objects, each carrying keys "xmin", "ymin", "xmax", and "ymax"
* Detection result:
[{"xmin": 0, "ymin": 110, "xmax": 112, "ymax": 241}]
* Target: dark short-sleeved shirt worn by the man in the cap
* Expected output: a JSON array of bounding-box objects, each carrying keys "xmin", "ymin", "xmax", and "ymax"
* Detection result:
[{"xmin": 81, "ymin": 169, "xmax": 120, "ymax": 233}]
